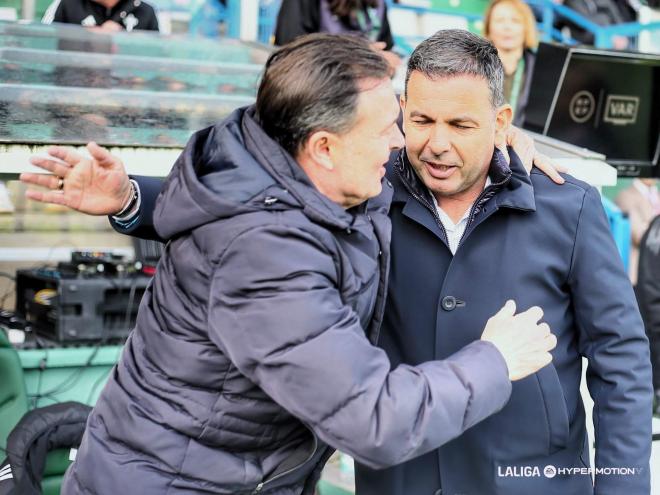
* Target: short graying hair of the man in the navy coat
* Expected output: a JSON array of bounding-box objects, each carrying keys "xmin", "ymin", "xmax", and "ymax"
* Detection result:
[{"xmin": 405, "ymin": 29, "xmax": 504, "ymax": 108}]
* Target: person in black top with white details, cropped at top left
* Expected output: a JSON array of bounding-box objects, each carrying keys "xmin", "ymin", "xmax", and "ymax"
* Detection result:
[{"xmin": 41, "ymin": 0, "xmax": 158, "ymax": 32}]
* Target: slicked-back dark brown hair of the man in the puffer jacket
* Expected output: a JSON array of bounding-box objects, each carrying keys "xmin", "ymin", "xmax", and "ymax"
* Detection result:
[{"xmin": 256, "ymin": 33, "xmax": 391, "ymax": 157}]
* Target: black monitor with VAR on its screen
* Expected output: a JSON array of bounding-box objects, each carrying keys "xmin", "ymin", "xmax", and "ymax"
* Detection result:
[{"xmin": 523, "ymin": 43, "xmax": 660, "ymax": 177}]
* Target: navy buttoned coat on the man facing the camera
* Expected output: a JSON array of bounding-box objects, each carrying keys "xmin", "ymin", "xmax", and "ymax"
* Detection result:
[{"xmin": 357, "ymin": 149, "xmax": 652, "ymax": 495}]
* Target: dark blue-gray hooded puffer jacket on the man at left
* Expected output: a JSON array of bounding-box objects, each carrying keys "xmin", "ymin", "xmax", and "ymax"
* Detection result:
[{"xmin": 63, "ymin": 109, "xmax": 511, "ymax": 495}]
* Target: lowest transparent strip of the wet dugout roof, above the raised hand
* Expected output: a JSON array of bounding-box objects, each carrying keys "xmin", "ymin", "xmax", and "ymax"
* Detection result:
[{"xmin": 0, "ymin": 84, "xmax": 254, "ymax": 147}]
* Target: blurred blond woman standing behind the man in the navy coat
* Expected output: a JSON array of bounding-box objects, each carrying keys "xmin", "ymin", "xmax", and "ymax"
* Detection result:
[{"xmin": 484, "ymin": 0, "xmax": 538, "ymax": 127}]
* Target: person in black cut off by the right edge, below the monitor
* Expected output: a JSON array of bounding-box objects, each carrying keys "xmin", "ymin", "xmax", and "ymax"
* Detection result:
[{"xmin": 637, "ymin": 216, "xmax": 660, "ymax": 414}]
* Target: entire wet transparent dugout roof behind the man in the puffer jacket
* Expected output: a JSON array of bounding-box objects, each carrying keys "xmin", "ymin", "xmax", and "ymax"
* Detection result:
[{"xmin": 0, "ymin": 22, "xmax": 271, "ymax": 148}]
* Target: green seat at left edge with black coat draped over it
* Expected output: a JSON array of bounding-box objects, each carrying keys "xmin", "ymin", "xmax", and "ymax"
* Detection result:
[{"xmin": 0, "ymin": 330, "xmax": 71, "ymax": 495}]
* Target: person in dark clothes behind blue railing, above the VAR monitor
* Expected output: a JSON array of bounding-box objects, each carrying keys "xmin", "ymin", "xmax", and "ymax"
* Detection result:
[{"xmin": 557, "ymin": 0, "xmax": 639, "ymax": 50}]
